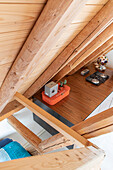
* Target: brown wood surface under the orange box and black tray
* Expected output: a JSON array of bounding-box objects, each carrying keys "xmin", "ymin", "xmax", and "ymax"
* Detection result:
[{"xmin": 35, "ymin": 65, "xmax": 113, "ymax": 124}]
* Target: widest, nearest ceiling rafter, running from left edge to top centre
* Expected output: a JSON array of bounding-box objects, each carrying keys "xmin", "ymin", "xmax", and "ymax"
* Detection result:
[{"xmin": 0, "ymin": 0, "xmax": 85, "ymax": 112}]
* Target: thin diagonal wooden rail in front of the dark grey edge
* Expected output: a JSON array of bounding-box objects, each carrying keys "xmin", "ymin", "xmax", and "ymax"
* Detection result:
[{"xmin": 14, "ymin": 92, "xmax": 92, "ymax": 147}]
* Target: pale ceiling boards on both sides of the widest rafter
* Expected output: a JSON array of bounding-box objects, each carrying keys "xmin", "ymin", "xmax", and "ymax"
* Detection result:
[{"xmin": 0, "ymin": 0, "xmax": 108, "ymax": 93}]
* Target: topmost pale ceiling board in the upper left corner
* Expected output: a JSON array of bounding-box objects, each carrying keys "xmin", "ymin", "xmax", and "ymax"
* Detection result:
[{"xmin": 0, "ymin": 4, "xmax": 45, "ymax": 33}]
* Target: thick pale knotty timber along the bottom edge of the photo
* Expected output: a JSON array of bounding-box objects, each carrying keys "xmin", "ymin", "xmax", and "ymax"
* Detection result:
[{"xmin": 0, "ymin": 147, "xmax": 105, "ymax": 170}]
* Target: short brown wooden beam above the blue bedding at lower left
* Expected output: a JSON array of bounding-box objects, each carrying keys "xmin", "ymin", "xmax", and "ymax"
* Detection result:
[{"xmin": 8, "ymin": 116, "xmax": 41, "ymax": 154}]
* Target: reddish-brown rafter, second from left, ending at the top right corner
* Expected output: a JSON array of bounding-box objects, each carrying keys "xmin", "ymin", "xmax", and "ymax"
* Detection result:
[{"xmin": 24, "ymin": 0, "xmax": 113, "ymax": 98}]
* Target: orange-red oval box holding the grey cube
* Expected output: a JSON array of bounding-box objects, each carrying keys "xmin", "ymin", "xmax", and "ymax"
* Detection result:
[{"xmin": 42, "ymin": 84, "xmax": 70, "ymax": 105}]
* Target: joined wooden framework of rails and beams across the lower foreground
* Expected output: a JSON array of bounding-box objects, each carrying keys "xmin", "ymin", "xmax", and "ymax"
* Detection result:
[{"xmin": 0, "ymin": 92, "xmax": 113, "ymax": 169}]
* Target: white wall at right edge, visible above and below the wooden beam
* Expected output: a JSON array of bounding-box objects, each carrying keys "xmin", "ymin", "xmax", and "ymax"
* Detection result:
[{"xmin": 88, "ymin": 92, "xmax": 113, "ymax": 170}]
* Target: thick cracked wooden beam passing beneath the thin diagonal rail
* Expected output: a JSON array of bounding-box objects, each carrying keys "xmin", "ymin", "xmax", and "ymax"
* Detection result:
[{"xmin": 39, "ymin": 108, "xmax": 113, "ymax": 152}]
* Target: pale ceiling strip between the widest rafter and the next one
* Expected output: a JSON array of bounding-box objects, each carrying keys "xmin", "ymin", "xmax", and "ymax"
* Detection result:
[{"xmin": 19, "ymin": 0, "xmax": 107, "ymax": 93}]
